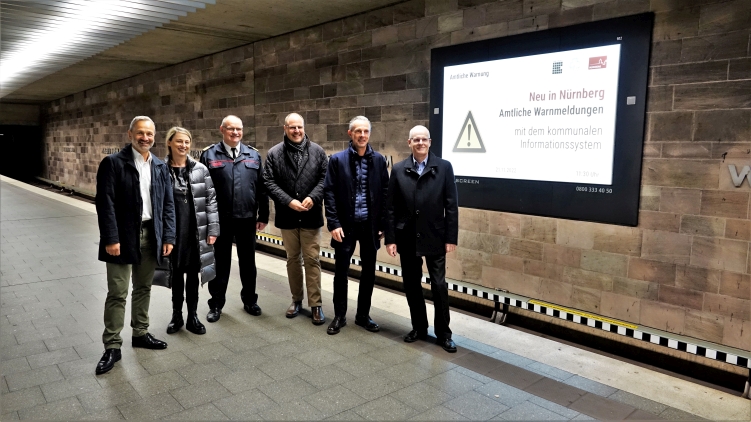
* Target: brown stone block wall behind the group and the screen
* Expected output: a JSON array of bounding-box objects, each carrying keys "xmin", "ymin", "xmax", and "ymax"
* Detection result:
[{"xmin": 46, "ymin": 0, "xmax": 751, "ymax": 350}]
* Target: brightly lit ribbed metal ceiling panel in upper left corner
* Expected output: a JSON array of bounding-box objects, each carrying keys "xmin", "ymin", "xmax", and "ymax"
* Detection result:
[{"xmin": 0, "ymin": 0, "xmax": 215, "ymax": 98}]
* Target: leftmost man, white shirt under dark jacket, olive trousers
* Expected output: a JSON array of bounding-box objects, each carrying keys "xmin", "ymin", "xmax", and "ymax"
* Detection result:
[{"xmin": 96, "ymin": 116, "xmax": 175, "ymax": 374}]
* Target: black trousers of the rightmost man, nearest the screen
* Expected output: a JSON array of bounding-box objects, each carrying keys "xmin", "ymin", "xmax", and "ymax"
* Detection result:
[{"xmin": 397, "ymin": 251, "xmax": 451, "ymax": 340}]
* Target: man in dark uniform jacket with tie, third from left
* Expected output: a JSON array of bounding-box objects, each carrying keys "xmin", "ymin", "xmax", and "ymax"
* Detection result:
[{"xmin": 201, "ymin": 116, "xmax": 269, "ymax": 322}]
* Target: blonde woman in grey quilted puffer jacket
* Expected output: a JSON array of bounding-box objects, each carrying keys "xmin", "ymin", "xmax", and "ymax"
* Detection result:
[{"xmin": 165, "ymin": 127, "xmax": 219, "ymax": 334}]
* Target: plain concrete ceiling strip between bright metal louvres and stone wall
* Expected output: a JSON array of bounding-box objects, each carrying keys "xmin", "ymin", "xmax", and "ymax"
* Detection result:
[{"xmin": 0, "ymin": 0, "xmax": 412, "ymax": 103}]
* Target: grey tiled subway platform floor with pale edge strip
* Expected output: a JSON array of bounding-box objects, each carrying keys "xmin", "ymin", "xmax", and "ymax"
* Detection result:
[{"xmin": 0, "ymin": 177, "xmax": 751, "ymax": 421}]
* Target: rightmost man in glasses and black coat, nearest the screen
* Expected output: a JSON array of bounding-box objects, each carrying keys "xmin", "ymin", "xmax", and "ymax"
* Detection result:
[{"xmin": 386, "ymin": 126, "xmax": 459, "ymax": 353}]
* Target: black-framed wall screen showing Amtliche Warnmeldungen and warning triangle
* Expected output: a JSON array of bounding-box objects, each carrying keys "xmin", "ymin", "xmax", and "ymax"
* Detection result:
[{"xmin": 430, "ymin": 13, "xmax": 654, "ymax": 226}]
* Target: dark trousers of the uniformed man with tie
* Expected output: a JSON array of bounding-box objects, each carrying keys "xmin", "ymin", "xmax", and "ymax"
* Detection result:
[{"xmin": 209, "ymin": 218, "xmax": 258, "ymax": 309}]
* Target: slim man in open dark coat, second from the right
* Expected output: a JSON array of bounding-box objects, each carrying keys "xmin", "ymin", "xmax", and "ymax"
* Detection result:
[{"xmin": 324, "ymin": 116, "xmax": 389, "ymax": 335}]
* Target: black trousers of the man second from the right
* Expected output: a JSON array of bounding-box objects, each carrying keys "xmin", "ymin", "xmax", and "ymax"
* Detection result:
[{"xmin": 334, "ymin": 221, "xmax": 376, "ymax": 317}]
